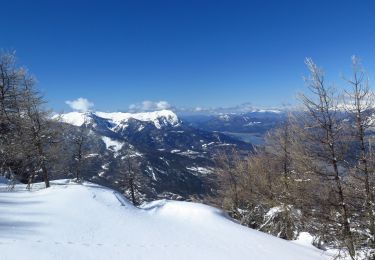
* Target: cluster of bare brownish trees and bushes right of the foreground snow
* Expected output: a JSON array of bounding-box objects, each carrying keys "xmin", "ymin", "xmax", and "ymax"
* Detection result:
[{"xmin": 214, "ymin": 57, "xmax": 375, "ymax": 259}]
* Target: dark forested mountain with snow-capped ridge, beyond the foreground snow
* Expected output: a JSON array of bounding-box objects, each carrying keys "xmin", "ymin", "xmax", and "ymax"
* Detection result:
[{"xmin": 54, "ymin": 110, "xmax": 252, "ymax": 201}]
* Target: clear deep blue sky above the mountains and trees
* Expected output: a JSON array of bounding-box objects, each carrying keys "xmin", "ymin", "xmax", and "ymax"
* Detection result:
[{"xmin": 0, "ymin": 0, "xmax": 375, "ymax": 111}]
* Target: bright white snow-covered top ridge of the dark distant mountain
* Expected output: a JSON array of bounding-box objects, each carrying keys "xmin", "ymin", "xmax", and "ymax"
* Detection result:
[{"xmin": 54, "ymin": 110, "xmax": 180, "ymax": 129}]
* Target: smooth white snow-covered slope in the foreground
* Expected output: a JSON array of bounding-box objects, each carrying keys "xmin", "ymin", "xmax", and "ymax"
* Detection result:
[{"xmin": 0, "ymin": 181, "xmax": 328, "ymax": 260}]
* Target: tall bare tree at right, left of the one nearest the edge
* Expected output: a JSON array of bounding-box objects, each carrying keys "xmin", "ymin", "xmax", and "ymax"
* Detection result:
[{"xmin": 301, "ymin": 59, "xmax": 355, "ymax": 259}]
